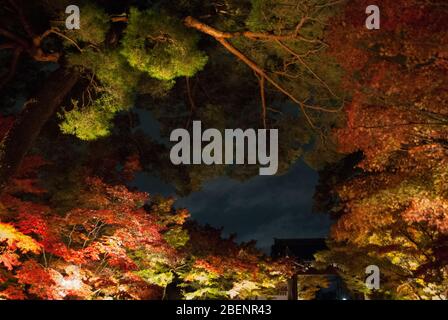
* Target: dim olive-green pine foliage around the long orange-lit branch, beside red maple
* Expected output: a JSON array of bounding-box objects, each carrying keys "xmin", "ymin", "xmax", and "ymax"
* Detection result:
[{"xmin": 243, "ymin": 0, "xmax": 342, "ymax": 99}]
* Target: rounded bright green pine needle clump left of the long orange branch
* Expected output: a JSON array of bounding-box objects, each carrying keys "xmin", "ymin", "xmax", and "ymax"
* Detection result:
[{"xmin": 122, "ymin": 9, "xmax": 207, "ymax": 81}]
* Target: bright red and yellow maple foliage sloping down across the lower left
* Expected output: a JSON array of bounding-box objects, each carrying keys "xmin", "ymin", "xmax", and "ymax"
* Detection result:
[{"xmin": 0, "ymin": 124, "xmax": 288, "ymax": 299}]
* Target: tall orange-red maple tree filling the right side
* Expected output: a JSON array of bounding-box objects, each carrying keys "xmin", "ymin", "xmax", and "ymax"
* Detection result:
[{"xmin": 316, "ymin": 0, "xmax": 448, "ymax": 299}]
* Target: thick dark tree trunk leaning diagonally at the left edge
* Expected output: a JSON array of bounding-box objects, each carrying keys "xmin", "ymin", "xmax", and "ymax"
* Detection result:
[{"xmin": 0, "ymin": 68, "xmax": 79, "ymax": 193}]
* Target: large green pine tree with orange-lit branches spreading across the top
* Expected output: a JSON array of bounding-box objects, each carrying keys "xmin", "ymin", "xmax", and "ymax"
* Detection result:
[{"xmin": 0, "ymin": 0, "xmax": 343, "ymax": 193}]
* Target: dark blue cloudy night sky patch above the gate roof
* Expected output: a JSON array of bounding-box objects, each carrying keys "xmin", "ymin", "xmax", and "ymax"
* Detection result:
[{"xmin": 133, "ymin": 112, "xmax": 331, "ymax": 252}]
